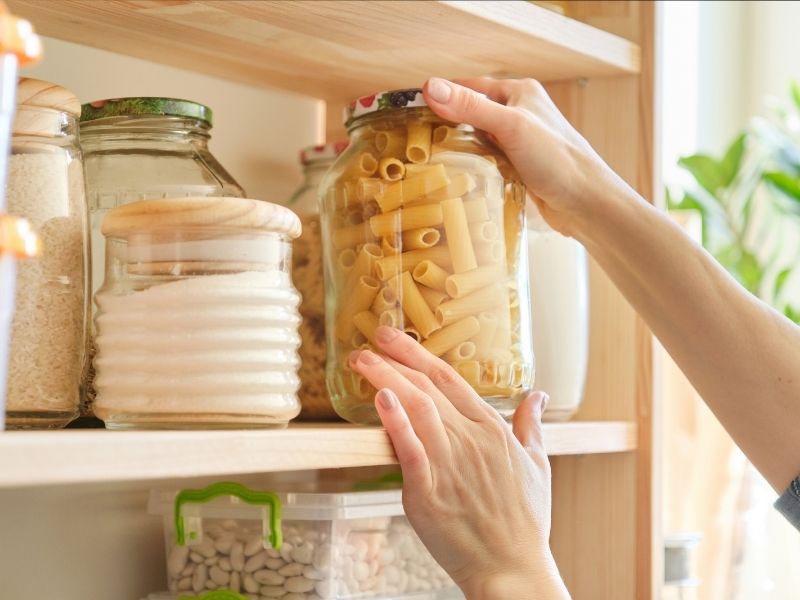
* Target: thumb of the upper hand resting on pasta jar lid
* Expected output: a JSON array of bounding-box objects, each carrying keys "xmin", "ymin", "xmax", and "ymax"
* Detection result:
[{"xmin": 422, "ymin": 77, "xmax": 516, "ymax": 138}]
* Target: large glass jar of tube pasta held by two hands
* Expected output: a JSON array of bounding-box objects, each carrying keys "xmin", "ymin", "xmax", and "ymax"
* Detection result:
[{"xmin": 321, "ymin": 89, "xmax": 534, "ymax": 424}]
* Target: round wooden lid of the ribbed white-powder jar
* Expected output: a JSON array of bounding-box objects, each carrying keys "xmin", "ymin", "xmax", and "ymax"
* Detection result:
[{"xmin": 101, "ymin": 196, "xmax": 301, "ymax": 238}]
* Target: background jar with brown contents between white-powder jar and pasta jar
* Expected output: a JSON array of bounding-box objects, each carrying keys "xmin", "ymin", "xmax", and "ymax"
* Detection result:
[{"xmin": 287, "ymin": 141, "xmax": 347, "ymax": 420}]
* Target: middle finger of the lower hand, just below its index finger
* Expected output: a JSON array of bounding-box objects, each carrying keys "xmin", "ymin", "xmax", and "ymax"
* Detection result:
[{"xmin": 350, "ymin": 350, "xmax": 450, "ymax": 458}]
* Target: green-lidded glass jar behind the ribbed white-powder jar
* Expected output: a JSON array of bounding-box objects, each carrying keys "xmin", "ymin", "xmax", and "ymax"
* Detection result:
[{"xmin": 80, "ymin": 98, "xmax": 245, "ymax": 416}]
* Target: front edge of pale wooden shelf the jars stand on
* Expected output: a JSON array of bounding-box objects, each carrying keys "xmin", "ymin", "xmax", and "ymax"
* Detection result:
[{"xmin": 0, "ymin": 421, "xmax": 636, "ymax": 488}]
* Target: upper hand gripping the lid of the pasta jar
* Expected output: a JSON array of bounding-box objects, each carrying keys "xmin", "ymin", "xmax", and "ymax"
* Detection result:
[{"xmin": 423, "ymin": 77, "xmax": 627, "ymax": 237}]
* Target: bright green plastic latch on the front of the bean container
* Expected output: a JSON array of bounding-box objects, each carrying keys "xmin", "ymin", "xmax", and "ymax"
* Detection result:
[{"xmin": 175, "ymin": 481, "xmax": 283, "ymax": 552}]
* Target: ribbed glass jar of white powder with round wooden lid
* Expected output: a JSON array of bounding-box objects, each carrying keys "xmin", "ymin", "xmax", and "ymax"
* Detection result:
[{"xmin": 94, "ymin": 197, "xmax": 300, "ymax": 429}]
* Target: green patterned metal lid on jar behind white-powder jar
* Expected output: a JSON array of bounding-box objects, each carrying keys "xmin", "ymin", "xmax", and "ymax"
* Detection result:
[{"xmin": 81, "ymin": 97, "xmax": 212, "ymax": 127}]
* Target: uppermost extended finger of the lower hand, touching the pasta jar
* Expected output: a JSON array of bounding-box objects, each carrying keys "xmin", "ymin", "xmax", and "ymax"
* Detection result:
[{"xmin": 375, "ymin": 327, "xmax": 489, "ymax": 421}]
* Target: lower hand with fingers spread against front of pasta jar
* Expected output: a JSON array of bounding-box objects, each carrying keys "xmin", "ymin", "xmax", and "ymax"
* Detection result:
[{"xmin": 350, "ymin": 327, "xmax": 569, "ymax": 600}]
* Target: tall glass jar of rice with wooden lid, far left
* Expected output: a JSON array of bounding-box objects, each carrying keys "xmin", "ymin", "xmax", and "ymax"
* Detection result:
[{"xmin": 6, "ymin": 79, "xmax": 88, "ymax": 428}]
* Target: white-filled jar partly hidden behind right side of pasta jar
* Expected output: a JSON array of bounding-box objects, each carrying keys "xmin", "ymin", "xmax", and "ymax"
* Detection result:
[{"xmin": 528, "ymin": 231, "xmax": 589, "ymax": 421}]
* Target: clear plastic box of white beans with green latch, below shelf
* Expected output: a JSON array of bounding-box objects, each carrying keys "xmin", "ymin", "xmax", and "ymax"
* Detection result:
[{"xmin": 149, "ymin": 483, "xmax": 463, "ymax": 600}]
